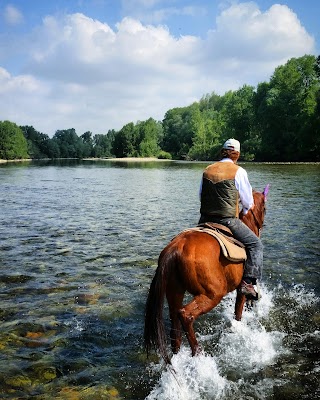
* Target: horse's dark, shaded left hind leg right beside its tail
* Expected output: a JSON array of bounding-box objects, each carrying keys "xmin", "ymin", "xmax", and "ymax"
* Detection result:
[{"xmin": 167, "ymin": 293, "xmax": 184, "ymax": 354}]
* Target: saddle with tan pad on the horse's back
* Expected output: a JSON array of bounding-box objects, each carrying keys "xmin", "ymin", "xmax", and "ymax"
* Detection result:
[{"xmin": 187, "ymin": 222, "xmax": 247, "ymax": 262}]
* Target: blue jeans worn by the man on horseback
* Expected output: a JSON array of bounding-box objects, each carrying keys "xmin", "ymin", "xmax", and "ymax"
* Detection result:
[{"xmin": 199, "ymin": 215, "xmax": 263, "ymax": 279}]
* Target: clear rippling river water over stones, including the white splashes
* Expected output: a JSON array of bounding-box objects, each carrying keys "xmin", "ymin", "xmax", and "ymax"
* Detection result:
[{"xmin": 0, "ymin": 161, "xmax": 320, "ymax": 400}]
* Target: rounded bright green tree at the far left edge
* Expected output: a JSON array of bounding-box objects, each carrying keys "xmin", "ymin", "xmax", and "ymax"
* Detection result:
[{"xmin": 0, "ymin": 121, "xmax": 29, "ymax": 160}]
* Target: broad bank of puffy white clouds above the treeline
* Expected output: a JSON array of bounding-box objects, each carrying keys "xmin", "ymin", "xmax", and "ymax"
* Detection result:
[{"xmin": 0, "ymin": 3, "xmax": 314, "ymax": 136}]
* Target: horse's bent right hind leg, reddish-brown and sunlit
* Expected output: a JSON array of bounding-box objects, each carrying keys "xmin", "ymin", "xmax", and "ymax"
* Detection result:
[{"xmin": 179, "ymin": 294, "xmax": 223, "ymax": 356}]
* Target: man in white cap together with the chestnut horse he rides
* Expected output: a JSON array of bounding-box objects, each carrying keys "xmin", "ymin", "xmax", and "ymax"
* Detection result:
[{"xmin": 144, "ymin": 139, "xmax": 269, "ymax": 363}]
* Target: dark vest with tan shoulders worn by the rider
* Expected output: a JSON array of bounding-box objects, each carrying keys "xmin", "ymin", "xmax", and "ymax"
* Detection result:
[{"xmin": 200, "ymin": 161, "xmax": 239, "ymax": 218}]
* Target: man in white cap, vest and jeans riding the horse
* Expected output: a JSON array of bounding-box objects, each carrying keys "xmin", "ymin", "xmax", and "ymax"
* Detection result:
[{"xmin": 199, "ymin": 139, "xmax": 263, "ymax": 300}]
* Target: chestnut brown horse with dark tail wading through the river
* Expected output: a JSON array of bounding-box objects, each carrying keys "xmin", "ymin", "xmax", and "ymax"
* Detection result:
[{"xmin": 144, "ymin": 185, "xmax": 269, "ymax": 363}]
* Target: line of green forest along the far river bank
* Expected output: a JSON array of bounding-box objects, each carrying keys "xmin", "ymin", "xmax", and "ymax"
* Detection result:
[{"xmin": 0, "ymin": 55, "xmax": 320, "ymax": 162}]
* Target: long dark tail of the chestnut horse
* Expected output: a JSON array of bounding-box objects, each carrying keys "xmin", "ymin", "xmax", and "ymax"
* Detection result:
[{"xmin": 144, "ymin": 248, "xmax": 176, "ymax": 364}]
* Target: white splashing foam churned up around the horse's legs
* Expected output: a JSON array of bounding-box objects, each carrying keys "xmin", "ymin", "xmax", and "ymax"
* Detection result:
[{"xmin": 146, "ymin": 288, "xmax": 285, "ymax": 400}]
